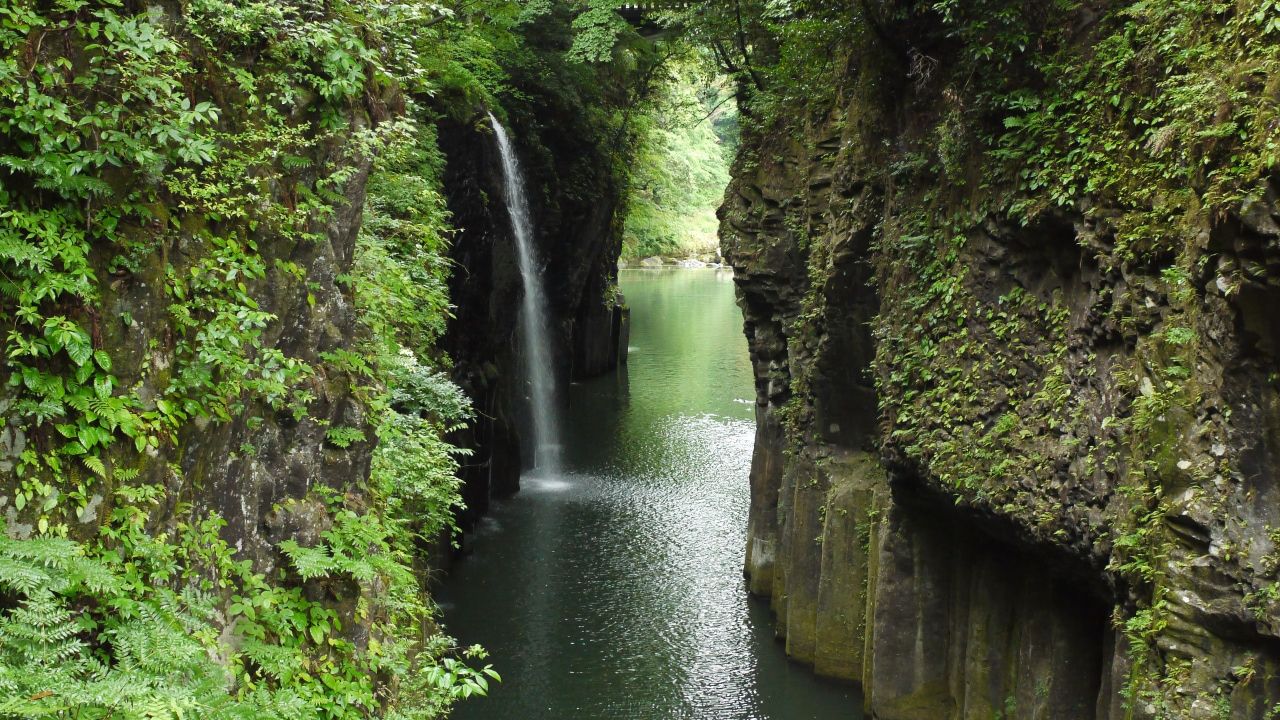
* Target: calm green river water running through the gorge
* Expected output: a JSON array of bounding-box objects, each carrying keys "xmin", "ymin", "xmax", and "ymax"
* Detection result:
[{"xmin": 440, "ymin": 269, "xmax": 861, "ymax": 720}]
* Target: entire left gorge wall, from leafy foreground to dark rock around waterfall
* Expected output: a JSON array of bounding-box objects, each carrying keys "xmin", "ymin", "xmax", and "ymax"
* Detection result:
[{"xmin": 0, "ymin": 0, "xmax": 627, "ymax": 719}]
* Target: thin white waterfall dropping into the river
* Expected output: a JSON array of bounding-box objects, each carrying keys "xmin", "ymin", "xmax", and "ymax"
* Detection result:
[{"xmin": 489, "ymin": 113, "xmax": 561, "ymax": 477}]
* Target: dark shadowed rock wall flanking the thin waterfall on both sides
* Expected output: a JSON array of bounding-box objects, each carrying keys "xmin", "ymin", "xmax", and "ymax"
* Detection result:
[{"xmin": 442, "ymin": 94, "xmax": 626, "ymax": 523}]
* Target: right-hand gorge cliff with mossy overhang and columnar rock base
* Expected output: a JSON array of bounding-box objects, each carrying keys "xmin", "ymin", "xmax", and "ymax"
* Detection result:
[{"xmin": 721, "ymin": 1, "xmax": 1280, "ymax": 720}]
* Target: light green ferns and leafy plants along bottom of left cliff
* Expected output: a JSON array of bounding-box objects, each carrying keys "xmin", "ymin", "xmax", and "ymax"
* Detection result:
[{"xmin": 0, "ymin": 487, "xmax": 490, "ymax": 719}]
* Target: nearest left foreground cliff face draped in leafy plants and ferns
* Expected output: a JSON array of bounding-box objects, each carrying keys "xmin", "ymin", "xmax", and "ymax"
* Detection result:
[{"xmin": 0, "ymin": 3, "xmax": 426, "ymax": 716}]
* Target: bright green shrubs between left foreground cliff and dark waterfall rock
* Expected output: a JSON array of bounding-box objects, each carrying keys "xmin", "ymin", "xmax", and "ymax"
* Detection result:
[{"xmin": 355, "ymin": 107, "xmax": 471, "ymax": 542}]
